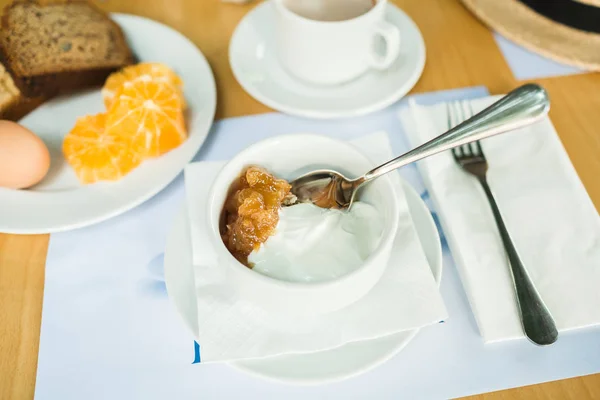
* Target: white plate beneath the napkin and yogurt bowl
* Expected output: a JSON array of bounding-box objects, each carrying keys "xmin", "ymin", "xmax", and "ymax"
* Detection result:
[{"xmin": 165, "ymin": 181, "xmax": 442, "ymax": 384}]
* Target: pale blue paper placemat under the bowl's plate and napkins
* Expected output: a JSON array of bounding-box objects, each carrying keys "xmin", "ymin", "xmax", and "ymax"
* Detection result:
[{"xmin": 35, "ymin": 88, "xmax": 600, "ymax": 400}]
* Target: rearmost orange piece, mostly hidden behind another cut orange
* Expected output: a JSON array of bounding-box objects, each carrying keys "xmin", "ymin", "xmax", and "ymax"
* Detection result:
[{"xmin": 102, "ymin": 62, "xmax": 185, "ymax": 110}]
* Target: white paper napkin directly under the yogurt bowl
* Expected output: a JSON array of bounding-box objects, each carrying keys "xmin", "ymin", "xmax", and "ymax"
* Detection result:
[{"xmin": 185, "ymin": 132, "xmax": 446, "ymax": 363}]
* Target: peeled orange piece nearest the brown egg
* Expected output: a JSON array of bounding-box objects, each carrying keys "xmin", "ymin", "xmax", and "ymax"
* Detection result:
[{"xmin": 63, "ymin": 114, "xmax": 142, "ymax": 183}]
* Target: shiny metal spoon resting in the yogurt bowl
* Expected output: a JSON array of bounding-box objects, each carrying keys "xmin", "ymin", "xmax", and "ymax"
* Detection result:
[{"xmin": 290, "ymin": 83, "xmax": 550, "ymax": 208}]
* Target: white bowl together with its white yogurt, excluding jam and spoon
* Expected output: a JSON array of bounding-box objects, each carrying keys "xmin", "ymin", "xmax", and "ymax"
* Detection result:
[{"xmin": 207, "ymin": 134, "xmax": 399, "ymax": 315}]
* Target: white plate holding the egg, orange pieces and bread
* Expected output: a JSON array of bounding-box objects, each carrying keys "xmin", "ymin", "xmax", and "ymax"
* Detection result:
[{"xmin": 0, "ymin": 14, "xmax": 216, "ymax": 233}]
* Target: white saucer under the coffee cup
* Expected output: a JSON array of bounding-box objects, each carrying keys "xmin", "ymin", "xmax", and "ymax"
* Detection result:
[{"xmin": 229, "ymin": 2, "xmax": 425, "ymax": 118}]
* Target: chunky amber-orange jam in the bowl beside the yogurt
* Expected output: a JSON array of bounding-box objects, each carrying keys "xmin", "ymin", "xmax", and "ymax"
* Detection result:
[{"xmin": 221, "ymin": 166, "xmax": 295, "ymax": 267}]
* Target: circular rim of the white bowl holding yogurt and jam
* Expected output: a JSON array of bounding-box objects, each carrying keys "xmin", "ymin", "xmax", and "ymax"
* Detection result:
[{"xmin": 205, "ymin": 132, "xmax": 400, "ymax": 291}]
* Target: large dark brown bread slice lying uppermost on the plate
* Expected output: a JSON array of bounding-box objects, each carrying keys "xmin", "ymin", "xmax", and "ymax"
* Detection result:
[{"xmin": 0, "ymin": 0, "xmax": 133, "ymax": 97}]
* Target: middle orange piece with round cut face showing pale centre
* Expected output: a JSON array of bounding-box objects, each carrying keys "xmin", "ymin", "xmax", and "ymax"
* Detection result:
[{"xmin": 106, "ymin": 80, "xmax": 187, "ymax": 157}]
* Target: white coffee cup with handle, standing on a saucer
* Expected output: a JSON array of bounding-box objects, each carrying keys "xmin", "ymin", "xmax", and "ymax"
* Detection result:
[{"xmin": 273, "ymin": 0, "xmax": 400, "ymax": 85}]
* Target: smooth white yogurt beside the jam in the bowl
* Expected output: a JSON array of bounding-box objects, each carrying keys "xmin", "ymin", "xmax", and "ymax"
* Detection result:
[{"xmin": 248, "ymin": 202, "xmax": 383, "ymax": 282}]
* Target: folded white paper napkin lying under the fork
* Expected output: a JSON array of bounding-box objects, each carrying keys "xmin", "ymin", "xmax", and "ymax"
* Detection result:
[{"xmin": 400, "ymin": 97, "xmax": 600, "ymax": 342}]
